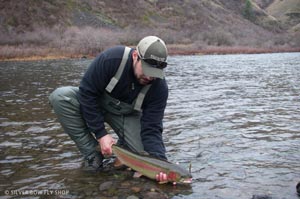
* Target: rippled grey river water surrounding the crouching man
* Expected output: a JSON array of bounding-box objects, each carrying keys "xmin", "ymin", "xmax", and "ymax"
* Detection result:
[{"xmin": 0, "ymin": 53, "xmax": 300, "ymax": 199}]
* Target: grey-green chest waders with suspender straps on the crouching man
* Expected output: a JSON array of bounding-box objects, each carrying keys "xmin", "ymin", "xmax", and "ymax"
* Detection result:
[{"xmin": 49, "ymin": 47, "xmax": 150, "ymax": 157}]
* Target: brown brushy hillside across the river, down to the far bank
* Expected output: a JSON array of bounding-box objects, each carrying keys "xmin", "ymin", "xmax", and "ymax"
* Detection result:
[{"xmin": 0, "ymin": 0, "xmax": 300, "ymax": 58}]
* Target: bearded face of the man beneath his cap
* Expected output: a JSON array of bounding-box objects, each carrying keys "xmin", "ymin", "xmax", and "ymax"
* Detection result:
[{"xmin": 133, "ymin": 50, "xmax": 155, "ymax": 85}]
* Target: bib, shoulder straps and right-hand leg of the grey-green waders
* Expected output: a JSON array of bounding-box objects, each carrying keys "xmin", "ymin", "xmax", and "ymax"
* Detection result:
[{"xmin": 99, "ymin": 47, "xmax": 151, "ymax": 152}]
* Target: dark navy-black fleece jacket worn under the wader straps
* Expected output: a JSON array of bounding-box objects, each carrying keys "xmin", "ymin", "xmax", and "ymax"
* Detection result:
[{"xmin": 78, "ymin": 46, "xmax": 168, "ymax": 159}]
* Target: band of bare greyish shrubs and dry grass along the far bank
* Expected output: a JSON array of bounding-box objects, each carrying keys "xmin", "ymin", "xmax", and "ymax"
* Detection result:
[{"xmin": 0, "ymin": 27, "xmax": 300, "ymax": 60}]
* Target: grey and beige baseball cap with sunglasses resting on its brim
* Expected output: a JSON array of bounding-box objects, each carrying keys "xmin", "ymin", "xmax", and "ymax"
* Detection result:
[{"xmin": 136, "ymin": 36, "xmax": 168, "ymax": 79}]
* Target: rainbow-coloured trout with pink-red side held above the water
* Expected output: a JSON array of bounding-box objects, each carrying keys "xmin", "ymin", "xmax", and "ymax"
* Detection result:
[{"xmin": 112, "ymin": 145, "xmax": 192, "ymax": 184}]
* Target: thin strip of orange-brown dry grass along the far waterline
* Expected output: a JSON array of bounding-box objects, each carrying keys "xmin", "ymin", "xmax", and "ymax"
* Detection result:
[{"xmin": 0, "ymin": 44, "xmax": 300, "ymax": 61}]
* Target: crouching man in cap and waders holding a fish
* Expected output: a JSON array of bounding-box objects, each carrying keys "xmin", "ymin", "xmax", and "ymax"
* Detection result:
[{"xmin": 49, "ymin": 36, "xmax": 168, "ymax": 181}]
